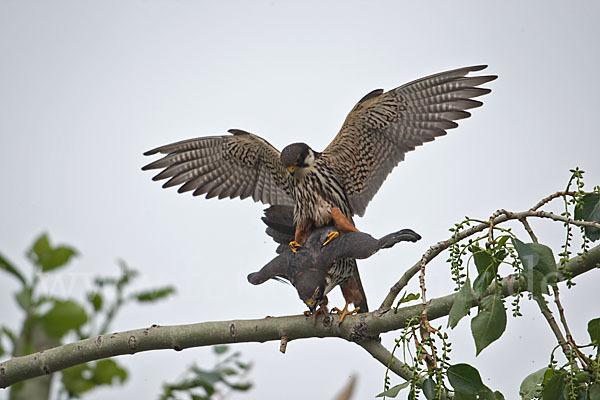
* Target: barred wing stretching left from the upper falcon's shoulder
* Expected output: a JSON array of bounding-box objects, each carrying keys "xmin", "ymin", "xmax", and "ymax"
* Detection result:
[{"xmin": 142, "ymin": 129, "xmax": 294, "ymax": 205}]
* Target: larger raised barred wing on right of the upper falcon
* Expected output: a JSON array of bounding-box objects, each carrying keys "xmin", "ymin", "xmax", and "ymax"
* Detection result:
[{"xmin": 321, "ymin": 65, "xmax": 497, "ymax": 216}]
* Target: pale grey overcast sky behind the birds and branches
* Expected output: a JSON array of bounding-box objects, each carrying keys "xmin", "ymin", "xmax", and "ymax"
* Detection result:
[{"xmin": 0, "ymin": 0, "xmax": 600, "ymax": 400}]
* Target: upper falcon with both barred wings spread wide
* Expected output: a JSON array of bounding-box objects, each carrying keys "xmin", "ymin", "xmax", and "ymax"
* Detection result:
[{"xmin": 143, "ymin": 65, "xmax": 497, "ymax": 318}]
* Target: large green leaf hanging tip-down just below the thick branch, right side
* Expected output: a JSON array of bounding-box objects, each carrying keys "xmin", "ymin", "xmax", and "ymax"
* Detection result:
[{"xmin": 471, "ymin": 295, "xmax": 506, "ymax": 355}]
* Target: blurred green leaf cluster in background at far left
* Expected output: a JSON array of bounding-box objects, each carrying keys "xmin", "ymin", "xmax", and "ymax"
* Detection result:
[{"xmin": 0, "ymin": 234, "xmax": 174, "ymax": 398}]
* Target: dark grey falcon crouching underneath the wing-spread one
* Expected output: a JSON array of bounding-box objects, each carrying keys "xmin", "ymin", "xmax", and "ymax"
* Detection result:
[{"xmin": 248, "ymin": 206, "xmax": 421, "ymax": 323}]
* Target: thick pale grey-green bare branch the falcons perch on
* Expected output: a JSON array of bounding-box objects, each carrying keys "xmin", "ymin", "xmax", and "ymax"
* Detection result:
[{"xmin": 0, "ymin": 242, "xmax": 600, "ymax": 388}]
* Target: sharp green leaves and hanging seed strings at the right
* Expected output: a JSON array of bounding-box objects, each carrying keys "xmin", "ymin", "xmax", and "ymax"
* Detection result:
[{"xmin": 379, "ymin": 169, "xmax": 600, "ymax": 400}]
